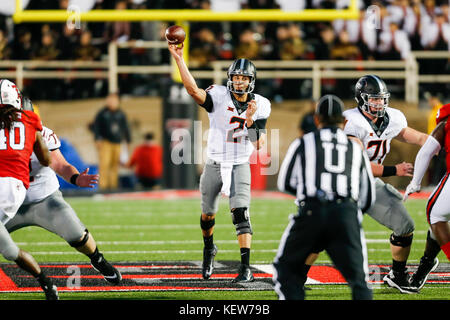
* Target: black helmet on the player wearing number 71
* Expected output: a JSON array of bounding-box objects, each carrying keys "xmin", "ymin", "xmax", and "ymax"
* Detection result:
[{"xmin": 355, "ymin": 74, "xmax": 390, "ymax": 117}]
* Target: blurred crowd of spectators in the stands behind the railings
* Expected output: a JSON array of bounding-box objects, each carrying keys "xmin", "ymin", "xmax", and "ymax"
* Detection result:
[{"xmin": 0, "ymin": 0, "xmax": 450, "ymax": 99}]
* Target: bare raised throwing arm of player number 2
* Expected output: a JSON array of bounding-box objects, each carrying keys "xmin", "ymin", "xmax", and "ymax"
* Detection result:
[{"xmin": 169, "ymin": 44, "xmax": 206, "ymax": 105}]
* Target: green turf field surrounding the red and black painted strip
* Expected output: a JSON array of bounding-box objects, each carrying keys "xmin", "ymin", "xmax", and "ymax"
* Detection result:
[{"xmin": 0, "ymin": 197, "xmax": 450, "ymax": 300}]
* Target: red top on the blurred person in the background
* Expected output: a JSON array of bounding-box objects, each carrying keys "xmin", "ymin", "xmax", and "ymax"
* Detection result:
[{"xmin": 130, "ymin": 144, "xmax": 163, "ymax": 179}]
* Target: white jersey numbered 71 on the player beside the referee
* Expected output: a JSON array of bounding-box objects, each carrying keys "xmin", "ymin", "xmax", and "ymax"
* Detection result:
[{"xmin": 343, "ymin": 107, "xmax": 408, "ymax": 164}]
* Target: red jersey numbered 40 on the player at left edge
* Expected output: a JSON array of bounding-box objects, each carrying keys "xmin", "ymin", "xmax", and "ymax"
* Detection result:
[{"xmin": 0, "ymin": 111, "xmax": 42, "ymax": 189}]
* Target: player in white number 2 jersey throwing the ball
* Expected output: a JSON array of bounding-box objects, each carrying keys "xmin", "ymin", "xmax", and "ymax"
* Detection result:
[{"xmin": 169, "ymin": 44, "xmax": 270, "ymax": 282}]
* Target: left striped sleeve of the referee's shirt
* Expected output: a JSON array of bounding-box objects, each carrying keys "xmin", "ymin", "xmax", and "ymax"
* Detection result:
[{"xmin": 277, "ymin": 139, "xmax": 301, "ymax": 195}]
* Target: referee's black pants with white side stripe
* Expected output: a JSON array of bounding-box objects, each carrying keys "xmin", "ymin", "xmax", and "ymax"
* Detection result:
[{"xmin": 273, "ymin": 199, "xmax": 372, "ymax": 300}]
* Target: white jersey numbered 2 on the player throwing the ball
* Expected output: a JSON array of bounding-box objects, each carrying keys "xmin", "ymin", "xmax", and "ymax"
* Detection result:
[{"xmin": 206, "ymin": 85, "xmax": 270, "ymax": 164}]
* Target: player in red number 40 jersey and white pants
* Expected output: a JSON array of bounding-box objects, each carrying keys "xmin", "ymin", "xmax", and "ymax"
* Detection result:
[{"xmin": 0, "ymin": 79, "xmax": 58, "ymax": 300}]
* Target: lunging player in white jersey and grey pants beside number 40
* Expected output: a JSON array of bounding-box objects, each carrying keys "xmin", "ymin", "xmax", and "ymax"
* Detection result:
[{"xmin": 5, "ymin": 98, "xmax": 122, "ymax": 284}]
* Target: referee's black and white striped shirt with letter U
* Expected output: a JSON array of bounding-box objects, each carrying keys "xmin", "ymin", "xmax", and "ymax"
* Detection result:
[{"xmin": 278, "ymin": 127, "xmax": 375, "ymax": 212}]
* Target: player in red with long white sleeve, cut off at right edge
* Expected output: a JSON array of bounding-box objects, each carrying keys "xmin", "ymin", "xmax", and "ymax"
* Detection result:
[{"xmin": 404, "ymin": 104, "xmax": 450, "ymax": 290}]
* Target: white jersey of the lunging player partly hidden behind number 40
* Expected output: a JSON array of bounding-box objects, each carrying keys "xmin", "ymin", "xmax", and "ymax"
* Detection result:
[{"xmin": 23, "ymin": 126, "xmax": 61, "ymax": 204}]
